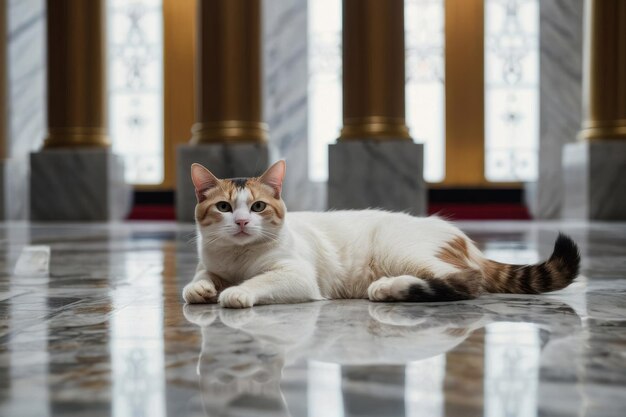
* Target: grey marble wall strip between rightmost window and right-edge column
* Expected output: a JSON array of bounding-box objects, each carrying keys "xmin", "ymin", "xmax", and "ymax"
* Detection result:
[{"xmin": 531, "ymin": 0, "xmax": 584, "ymax": 219}]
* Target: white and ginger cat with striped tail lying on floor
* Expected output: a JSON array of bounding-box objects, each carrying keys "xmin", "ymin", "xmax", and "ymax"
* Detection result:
[{"xmin": 183, "ymin": 161, "xmax": 580, "ymax": 308}]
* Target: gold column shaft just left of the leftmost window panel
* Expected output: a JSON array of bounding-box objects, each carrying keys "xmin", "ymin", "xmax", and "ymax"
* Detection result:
[{"xmin": 44, "ymin": 0, "xmax": 110, "ymax": 148}]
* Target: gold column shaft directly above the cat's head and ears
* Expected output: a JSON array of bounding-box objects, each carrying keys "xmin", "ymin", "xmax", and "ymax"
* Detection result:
[{"xmin": 191, "ymin": 0, "xmax": 267, "ymax": 144}]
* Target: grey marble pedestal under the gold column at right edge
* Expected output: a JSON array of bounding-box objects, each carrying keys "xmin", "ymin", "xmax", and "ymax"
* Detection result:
[{"xmin": 562, "ymin": 140, "xmax": 626, "ymax": 220}]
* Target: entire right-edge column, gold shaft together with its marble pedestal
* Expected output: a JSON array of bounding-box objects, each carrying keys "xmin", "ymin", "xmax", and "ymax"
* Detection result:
[{"xmin": 563, "ymin": 0, "xmax": 626, "ymax": 220}]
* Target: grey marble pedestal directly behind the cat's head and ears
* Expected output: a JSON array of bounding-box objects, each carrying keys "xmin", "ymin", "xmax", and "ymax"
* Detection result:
[{"xmin": 176, "ymin": 143, "xmax": 272, "ymax": 222}]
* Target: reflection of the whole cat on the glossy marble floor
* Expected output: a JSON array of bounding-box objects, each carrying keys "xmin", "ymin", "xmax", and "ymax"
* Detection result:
[{"xmin": 184, "ymin": 297, "xmax": 580, "ymax": 417}]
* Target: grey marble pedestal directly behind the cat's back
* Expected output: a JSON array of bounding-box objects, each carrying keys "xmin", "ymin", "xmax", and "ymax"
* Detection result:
[{"xmin": 328, "ymin": 140, "xmax": 427, "ymax": 215}]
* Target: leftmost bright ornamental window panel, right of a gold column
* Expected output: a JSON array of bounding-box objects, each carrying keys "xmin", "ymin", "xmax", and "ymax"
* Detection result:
[{"xmin": 107, "ymin": 0, "xmax": 164, "ymax": 184}]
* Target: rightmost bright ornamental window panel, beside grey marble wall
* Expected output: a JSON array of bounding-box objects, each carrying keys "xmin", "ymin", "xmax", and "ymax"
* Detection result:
[{"xmin": 485, "ymin": 0, "xmax": 539, "ymax": 181}]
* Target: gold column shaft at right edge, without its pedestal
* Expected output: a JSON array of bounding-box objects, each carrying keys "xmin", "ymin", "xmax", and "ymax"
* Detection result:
[{"xmin": 580, "ymin": 0, "xmax": 626, "ymax": 140}]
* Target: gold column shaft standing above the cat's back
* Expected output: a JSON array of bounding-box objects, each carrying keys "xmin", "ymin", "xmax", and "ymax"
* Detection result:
[{"xmin": 339, "ymin": 0, "xmax": 410, "ymax": 140}]
